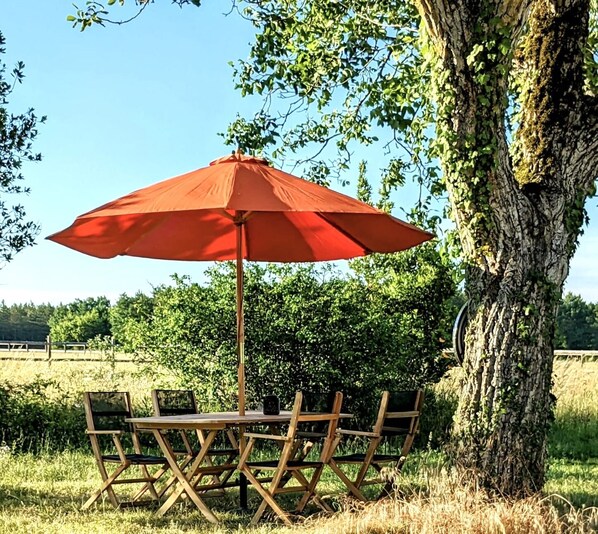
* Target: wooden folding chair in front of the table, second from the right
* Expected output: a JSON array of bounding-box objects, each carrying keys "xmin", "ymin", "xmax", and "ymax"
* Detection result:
[{"xmin": 239, "ymin": 392, "xmax": 343, "ymax": 525}]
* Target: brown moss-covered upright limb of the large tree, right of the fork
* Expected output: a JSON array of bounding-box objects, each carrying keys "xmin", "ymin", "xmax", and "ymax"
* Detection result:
[{"xmin": 514, "ymin": 0, "xmax": 589, "ymax": 189}]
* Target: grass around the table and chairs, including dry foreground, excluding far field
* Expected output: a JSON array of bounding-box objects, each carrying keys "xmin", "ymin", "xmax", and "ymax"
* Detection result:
[{"xmin": 0, "ymin": 451, "xmax": 598, "ymax": 534}]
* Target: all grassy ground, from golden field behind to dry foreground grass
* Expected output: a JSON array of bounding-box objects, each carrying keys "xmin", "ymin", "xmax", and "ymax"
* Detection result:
[{"xmin": 0, "ymin": 362, "xmax": 598, "ymax": 534}]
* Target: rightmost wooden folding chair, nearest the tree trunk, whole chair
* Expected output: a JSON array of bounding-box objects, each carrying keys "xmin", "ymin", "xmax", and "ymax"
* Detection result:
[{"xmin": 328, "ymin": 390, "xmax": 424, "ymax": 501}]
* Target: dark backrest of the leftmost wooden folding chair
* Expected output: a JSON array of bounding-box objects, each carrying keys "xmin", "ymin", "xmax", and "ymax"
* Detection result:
[{"xmin": 83, "ymin": 391, "xmax": 131, "ymax": 432}]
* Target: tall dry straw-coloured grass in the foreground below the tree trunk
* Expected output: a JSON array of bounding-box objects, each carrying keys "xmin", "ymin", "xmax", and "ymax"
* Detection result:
[{"xmin": 287, "ymin": 469, "xmax": 598, "ymax": 534}]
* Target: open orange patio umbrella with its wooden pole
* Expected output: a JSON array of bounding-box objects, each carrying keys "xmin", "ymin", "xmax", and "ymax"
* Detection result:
[{"xmin": 48, "ymin": 153, "xmax": 433, "ymax": 414}]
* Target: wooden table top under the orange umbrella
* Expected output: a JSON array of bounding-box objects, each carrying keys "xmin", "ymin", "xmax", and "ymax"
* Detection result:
[{"xmin": 127, "ymin": 410, "xmax": 351, "ymax": 428}]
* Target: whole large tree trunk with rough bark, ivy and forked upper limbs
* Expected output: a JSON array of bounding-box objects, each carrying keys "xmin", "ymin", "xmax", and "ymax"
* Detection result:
[{"xmin": 418, "ymin": 0, "xmax": 598, "ymax": 496}]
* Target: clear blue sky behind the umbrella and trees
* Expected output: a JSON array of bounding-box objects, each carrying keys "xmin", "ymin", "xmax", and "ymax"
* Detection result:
[{"xmin": 0, "ymin": 0, "xmax": 598, "ymax": 304}]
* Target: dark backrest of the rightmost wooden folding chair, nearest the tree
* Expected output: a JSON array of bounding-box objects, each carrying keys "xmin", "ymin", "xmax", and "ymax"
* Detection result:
[{"xmin": 374, "ymin": 389, "xmax": 424, "ymax": 437}]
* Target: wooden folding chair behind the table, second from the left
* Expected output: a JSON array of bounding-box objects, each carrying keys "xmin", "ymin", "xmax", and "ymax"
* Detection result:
[{"xmin": 152, "ymin": 389, "xmax": 239, "ymax": 489}]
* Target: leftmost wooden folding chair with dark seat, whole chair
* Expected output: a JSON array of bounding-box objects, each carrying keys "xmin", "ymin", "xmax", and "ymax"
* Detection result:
[{"xmin": 82, "ymin": 391, "xmax": 169, "ymax": 510}]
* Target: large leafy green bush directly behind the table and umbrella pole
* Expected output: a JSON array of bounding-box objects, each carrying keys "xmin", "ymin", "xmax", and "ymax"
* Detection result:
[{"xmin": 124, "ymin": 245, "xmax": 455, "ymax": 424}]
